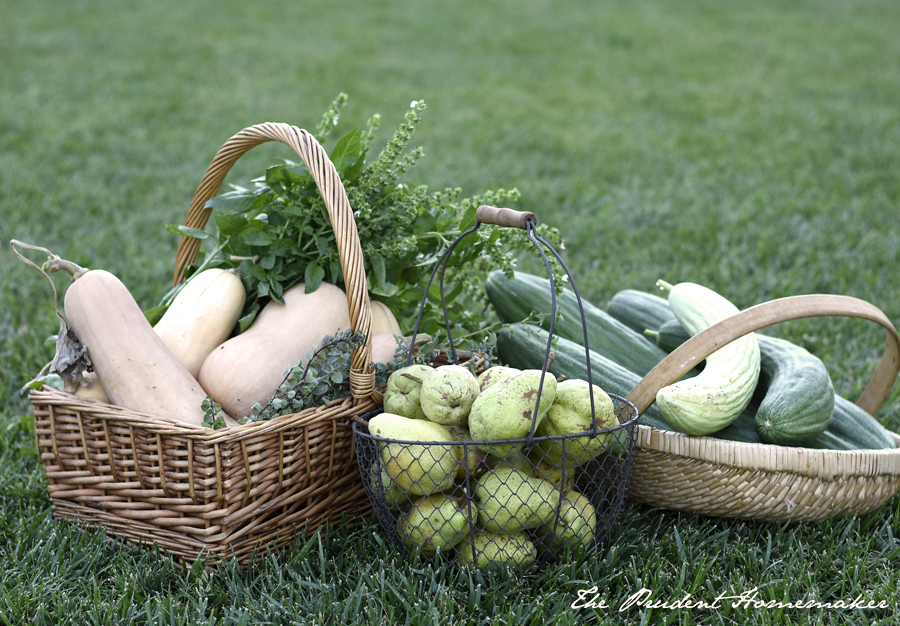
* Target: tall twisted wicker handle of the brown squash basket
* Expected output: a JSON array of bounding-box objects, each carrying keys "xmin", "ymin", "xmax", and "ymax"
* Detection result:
[{"xmin": 173, "ymin": 123, "xmax": 375, "ymax": 399}]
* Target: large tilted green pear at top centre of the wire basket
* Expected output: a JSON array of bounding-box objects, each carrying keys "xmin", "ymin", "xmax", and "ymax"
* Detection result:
[{"xmin": 469, "ymin": 370, "xmax": 557, "ymax": 456}]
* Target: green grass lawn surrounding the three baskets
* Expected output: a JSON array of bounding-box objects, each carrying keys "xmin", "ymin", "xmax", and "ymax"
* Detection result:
[{"xmin": 0, "ymin": 0, "xmax": 900, "ymax": 624}]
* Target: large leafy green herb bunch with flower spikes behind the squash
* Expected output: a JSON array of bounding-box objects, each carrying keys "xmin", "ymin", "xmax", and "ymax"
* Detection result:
[{"xmin": 162, "ymin": 94, "xmax": 563, "ymax": 335}]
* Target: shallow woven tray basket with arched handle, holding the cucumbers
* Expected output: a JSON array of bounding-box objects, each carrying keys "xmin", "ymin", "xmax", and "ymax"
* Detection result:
[{"xmin": 628, "ymin": 294, "xmax": 900, "ymax": 521}]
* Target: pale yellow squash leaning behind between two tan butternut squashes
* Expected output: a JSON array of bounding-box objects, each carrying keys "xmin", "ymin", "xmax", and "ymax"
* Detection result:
[{"xmin": 154, "ymin": 268, "xmax": 246, "ymax": 378}]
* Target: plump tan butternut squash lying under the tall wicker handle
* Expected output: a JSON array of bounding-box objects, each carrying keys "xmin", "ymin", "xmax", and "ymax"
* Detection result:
[{"xmin": 200, "ymin": 282, "xmax": 350, "ymax": 419}]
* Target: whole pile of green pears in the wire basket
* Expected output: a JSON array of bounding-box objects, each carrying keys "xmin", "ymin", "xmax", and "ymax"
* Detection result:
[{"xmin": 369, "ymin": 358, "xmax": 619, "ymax": 569}]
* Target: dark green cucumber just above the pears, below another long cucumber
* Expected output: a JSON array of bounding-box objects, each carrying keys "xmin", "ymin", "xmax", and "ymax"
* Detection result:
[{"xmin": 497, "ymin": 324, "xmax": 674, "ymax": 431}]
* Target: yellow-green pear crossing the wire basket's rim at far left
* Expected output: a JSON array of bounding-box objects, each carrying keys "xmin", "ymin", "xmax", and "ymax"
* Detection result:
[{"xmin": 369, "ymin": 413, "xmax": 459, "ymax": 496}]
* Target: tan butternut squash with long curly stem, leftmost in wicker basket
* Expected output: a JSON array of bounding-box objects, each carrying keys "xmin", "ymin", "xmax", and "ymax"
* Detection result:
[{"xmin": 56, "ymin": 264, "xmax": 235, "ymax": 426}]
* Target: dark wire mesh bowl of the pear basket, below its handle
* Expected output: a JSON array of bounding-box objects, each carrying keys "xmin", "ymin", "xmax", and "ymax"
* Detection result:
[{"xmin": 354, "ymin": 394, "xmax": 638, "ymax": 569}]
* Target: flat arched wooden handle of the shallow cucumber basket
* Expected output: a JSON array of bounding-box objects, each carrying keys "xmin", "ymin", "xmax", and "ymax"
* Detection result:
[{"xmin": 628, "ymin": 294, "xmax": 900, "ymax": 415}]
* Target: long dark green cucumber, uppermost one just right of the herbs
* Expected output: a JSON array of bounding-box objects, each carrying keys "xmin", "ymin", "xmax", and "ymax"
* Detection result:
[{"xmin": 485, "ymin": 271, "xmax": 666, "ymax": 376}]
